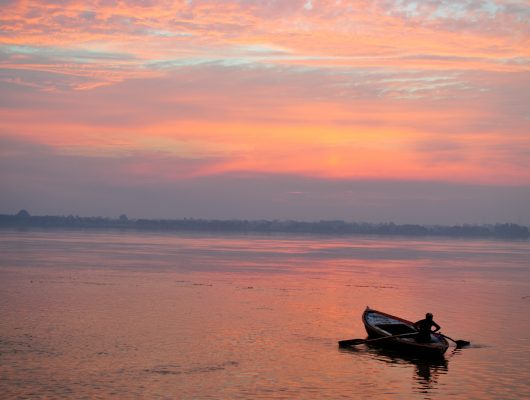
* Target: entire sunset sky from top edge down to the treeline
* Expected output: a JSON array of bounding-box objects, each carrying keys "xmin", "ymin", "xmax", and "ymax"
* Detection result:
[{"xmin": 0, "ymin": 0, "xmax": 530, "ymax": 225}]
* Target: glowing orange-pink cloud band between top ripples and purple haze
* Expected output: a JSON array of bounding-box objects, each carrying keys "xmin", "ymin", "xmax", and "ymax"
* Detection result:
[{"xmin": 0, "ymin": 60, "xmax": 530, "ymax": 183}]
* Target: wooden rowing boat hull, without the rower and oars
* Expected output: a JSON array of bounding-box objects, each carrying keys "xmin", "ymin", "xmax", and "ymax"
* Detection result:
[{"xmin": 363, "ymin": 307, "xmax": 449, "ymax": 356}]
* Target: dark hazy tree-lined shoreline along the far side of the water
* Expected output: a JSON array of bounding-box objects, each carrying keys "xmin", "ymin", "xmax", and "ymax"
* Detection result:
[{"xmin": 0, "ymin": 210, "xmax": 530, "ymax": 239}]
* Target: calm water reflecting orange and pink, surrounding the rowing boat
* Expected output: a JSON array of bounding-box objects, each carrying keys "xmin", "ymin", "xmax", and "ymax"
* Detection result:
[{"xmin": 0, "ymin": 231, "xmax": 530, "ymax": 399}]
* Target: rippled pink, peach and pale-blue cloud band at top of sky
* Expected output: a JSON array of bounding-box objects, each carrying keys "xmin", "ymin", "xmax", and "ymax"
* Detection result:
[{"xmin": 0, "ymin": 0, "xmax": 530, "ymax": 99}]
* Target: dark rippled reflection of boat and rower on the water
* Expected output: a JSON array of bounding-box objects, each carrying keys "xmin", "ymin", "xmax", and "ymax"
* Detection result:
[{"xmin": 344, "ymin": 344, "xmax": 450, "ymax": 398}]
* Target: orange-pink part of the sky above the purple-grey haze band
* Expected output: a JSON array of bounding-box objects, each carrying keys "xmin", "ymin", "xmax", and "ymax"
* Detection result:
[{"xmin": 0, "ymin": 0, "xmax": 530, "ymax": 220}]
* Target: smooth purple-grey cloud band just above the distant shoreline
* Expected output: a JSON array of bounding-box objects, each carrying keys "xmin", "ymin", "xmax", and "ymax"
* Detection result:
[{"xmin": 0, "ymin": 135, "xmax": 530, "ymax": 224}]
